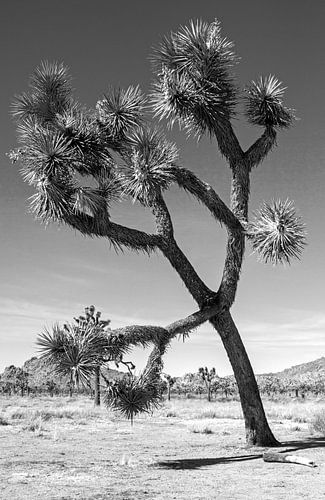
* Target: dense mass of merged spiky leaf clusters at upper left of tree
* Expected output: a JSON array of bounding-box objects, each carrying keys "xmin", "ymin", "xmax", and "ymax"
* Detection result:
[{"xmin": 10, "ymin": 63, "xmax": 182, "ymax": 225}]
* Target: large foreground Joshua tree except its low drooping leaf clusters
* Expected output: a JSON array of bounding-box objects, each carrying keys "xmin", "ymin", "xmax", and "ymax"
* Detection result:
[{"xmin": 10, "ymin": 21, "xmax": 304, "ymax": 446}]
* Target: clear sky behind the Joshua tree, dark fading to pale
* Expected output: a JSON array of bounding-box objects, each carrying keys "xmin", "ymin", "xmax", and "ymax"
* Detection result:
[{"xmin": 0, "ymin": 0, "xmax": 325, "ymax": 375}]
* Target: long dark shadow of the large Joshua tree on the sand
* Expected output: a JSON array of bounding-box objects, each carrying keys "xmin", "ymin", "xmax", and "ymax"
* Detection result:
[{"xmin": 153, "ymin": 437, "xmax": 325, "ymax": 469}]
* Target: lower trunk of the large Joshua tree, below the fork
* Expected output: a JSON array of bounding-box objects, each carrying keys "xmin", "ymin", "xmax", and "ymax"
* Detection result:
[{"xmin": 210, "ymin": 312, "xmax": 280, "ymax": 446}]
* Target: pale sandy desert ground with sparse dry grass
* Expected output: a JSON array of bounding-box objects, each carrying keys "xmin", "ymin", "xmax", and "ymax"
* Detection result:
[{"xmin": 0, "ymin": 398, "xmax": 325, "ymax": 500}]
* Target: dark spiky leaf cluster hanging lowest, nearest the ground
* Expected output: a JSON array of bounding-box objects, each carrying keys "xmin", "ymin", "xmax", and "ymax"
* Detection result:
[{"xmin": 104, "ymin": 376, "xmax": 162, "ymax": 424}]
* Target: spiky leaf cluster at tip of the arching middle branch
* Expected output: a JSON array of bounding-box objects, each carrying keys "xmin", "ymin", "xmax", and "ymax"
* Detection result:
[{"xmin": 121, "ymin": 128, "xmax": 178, "ymax": 205}]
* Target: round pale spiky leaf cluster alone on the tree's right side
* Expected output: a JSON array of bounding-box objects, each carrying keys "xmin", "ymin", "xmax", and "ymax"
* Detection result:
[{"xmin": 247, "ymin": 200, "xmax": 306, "ymax": 265}]
